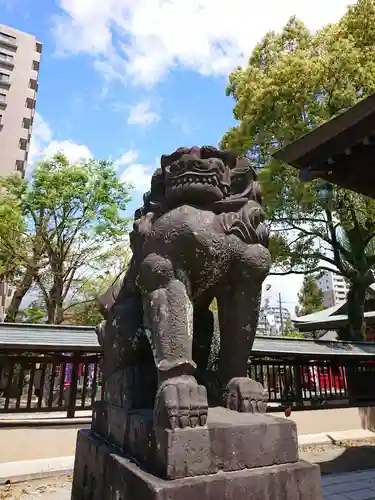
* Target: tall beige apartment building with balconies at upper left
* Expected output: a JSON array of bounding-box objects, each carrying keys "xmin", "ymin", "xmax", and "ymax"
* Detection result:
[{"xmin": 0, "ymin": 24, "xmax": 42, "ymax": 175}]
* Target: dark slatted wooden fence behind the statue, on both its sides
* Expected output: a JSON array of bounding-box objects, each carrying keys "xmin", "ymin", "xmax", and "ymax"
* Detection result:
[{"xmin": 0, "ymin": 351, "xmax": 375, "ymax": 418}]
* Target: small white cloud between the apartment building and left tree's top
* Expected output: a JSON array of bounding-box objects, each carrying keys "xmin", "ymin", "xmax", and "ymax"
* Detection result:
[{"xmin": 28, "ymin": 113, "xmax": 92, "ymax": 169}]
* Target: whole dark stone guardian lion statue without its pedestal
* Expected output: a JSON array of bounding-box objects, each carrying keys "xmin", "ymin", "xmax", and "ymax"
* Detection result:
[{"xmin": 98, "ymin": 146, "xmax": 271, "ymax": 429}]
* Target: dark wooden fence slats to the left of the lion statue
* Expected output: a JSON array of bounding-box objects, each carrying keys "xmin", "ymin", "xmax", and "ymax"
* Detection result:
[{"xmin": 0, "ymin": 353, "xmax": 102, "ymax": 417}]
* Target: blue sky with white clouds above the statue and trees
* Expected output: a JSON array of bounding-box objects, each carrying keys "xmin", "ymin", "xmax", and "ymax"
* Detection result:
[{"xmin": 0, "ymin": 0, "xmax": 353, "ymax": 309}]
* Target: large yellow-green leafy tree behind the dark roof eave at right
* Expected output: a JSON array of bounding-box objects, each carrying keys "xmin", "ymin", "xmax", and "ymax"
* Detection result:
[{"xmin": 222, "ymin": 0, "xmax": 375, "ymax": 339}]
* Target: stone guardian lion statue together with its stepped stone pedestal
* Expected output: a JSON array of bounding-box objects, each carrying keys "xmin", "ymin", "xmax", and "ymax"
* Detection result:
[{"xmin": 72, "ymin": 146, "xmax": 322, "ymax": 500}]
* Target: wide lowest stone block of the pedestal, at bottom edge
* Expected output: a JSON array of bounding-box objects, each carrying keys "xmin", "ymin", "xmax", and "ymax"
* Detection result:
[{"xmin": 71, "ymin": 431, "xmax": 323, "ymax": 500}]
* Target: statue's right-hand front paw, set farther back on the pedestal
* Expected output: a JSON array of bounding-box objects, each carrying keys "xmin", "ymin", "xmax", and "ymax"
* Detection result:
[{"xmin": 224, "ymin": 377, "xmax": 268, "ymax": 413}]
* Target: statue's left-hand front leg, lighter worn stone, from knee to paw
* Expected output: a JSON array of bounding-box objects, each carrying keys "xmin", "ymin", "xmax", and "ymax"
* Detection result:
[{"xmin": 138, "ymin": 254, "xmax": 207, "ymax": 430}]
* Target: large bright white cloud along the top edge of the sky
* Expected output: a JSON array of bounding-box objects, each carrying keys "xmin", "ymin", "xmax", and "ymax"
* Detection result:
[{"xmin": 53, "ymin": 0, "xmax": 355, "ymax": 85}]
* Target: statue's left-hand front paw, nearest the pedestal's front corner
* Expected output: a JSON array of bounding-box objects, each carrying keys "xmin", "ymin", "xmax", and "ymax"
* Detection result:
[{"xmin": 154, "ymin": 375, "xmax": 208, "ymax": 429}]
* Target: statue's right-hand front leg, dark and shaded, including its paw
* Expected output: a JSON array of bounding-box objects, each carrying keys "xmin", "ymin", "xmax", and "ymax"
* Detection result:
[{"xmin": 217, "ymin": 245, "xmax": 270, "ymax": 412}]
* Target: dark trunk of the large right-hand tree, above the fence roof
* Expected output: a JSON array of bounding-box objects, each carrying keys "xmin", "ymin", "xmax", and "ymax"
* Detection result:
[{"xmin": 346, "ymin": 280, "xmax": 368, "ymax": 341}]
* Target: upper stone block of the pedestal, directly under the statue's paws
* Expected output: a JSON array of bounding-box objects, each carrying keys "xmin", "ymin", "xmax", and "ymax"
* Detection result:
[{"xmin": 92, "ymin": 402, "xmax": 298, "ymax": 479}]
